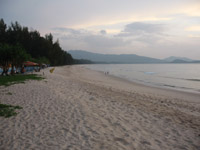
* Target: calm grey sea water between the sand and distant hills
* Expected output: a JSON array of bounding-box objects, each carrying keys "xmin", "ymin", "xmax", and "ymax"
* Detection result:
[{"xmin": 84, "ymin": 64, "xmax": 200, "ymax": 93}]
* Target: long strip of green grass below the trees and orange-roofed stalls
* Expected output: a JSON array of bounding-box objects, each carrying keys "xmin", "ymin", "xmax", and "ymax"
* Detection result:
[{"xmin": 0, "ymin": 74, "xmax": 44, "ymax": 86}]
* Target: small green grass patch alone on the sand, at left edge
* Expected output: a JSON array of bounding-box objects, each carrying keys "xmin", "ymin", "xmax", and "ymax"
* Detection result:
[{"xmin": 0, "ymin": 104, "xmax": 22, "ymax": 118}]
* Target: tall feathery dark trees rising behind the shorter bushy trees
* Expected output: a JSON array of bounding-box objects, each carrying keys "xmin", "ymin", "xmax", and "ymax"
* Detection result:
[{"xmin": 0, "ymin": 19, "xmax": 73, "ymax": 66}]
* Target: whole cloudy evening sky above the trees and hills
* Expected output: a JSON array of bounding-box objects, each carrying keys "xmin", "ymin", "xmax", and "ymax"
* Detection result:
[{"xmin": 0, "ymin": 0, "xmax": 200, "ymax": 60}]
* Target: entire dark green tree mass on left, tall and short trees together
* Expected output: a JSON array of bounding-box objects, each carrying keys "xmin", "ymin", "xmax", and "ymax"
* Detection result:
[{"xmin": 0, "ymin": 19, "xmax": 73, "ymax": 74}]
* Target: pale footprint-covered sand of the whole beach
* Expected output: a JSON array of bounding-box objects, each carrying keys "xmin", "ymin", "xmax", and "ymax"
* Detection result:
[{"xmin": 0, "ymin": 66, "xmax": 200, "ymax": 150}]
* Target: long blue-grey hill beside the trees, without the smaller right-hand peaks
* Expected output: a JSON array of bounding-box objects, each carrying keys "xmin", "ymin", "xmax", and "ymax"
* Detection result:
[{"xmin": 68, "ymin": 50, "xmax": 164, "ymax": 64}]
